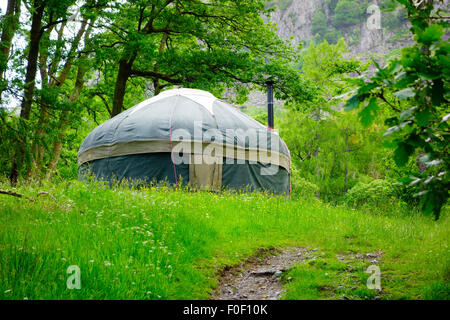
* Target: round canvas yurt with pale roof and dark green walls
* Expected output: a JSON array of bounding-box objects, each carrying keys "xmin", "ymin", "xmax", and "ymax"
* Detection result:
[{"xmin": 78, "ymin": 89, "xmax": 290, "ymax": 195}]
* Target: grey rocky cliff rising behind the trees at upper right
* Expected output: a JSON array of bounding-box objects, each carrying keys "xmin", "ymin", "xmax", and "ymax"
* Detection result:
[{"xmin": 271, "ymin": 0, "xmax": 411, "ymax": 56}]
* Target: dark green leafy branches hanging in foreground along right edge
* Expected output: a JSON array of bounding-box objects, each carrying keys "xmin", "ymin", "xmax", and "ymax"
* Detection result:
[{"xmin": 347, "ymin": 0, "xmax": 450, "ymax": 219}]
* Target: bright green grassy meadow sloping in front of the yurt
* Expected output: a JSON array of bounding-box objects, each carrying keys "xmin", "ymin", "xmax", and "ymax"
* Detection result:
[{"xmin": 0, "ymin": 181, "xmax": 450, "ymax": 299}]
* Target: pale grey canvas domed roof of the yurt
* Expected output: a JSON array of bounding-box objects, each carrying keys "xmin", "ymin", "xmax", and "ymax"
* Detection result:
[{"xmin": 78, "ymin": 89, "xmax": 289, "ymax": 168}]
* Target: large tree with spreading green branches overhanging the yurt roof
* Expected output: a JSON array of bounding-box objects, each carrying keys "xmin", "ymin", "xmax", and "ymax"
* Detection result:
[{"xmin": 92, "ymin": 0, "xmax": 308, "ymax": 116}]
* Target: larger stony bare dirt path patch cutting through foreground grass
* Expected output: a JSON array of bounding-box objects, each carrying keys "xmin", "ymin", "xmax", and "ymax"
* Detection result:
[{"xmin": 211, "ymin": 248, "xmax": 306, "ymax": 300}]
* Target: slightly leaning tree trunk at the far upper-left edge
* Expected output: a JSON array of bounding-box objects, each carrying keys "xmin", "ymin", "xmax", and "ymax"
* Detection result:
[{"xmin": 0, "ymin": 0, "xmax": 21, "ymax": 103}]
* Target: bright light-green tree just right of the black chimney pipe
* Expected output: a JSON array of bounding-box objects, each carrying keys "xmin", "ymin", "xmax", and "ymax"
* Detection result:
[{"xmin": 280, "ymin": 39, "xmax": 366, "ymax": 199}]
